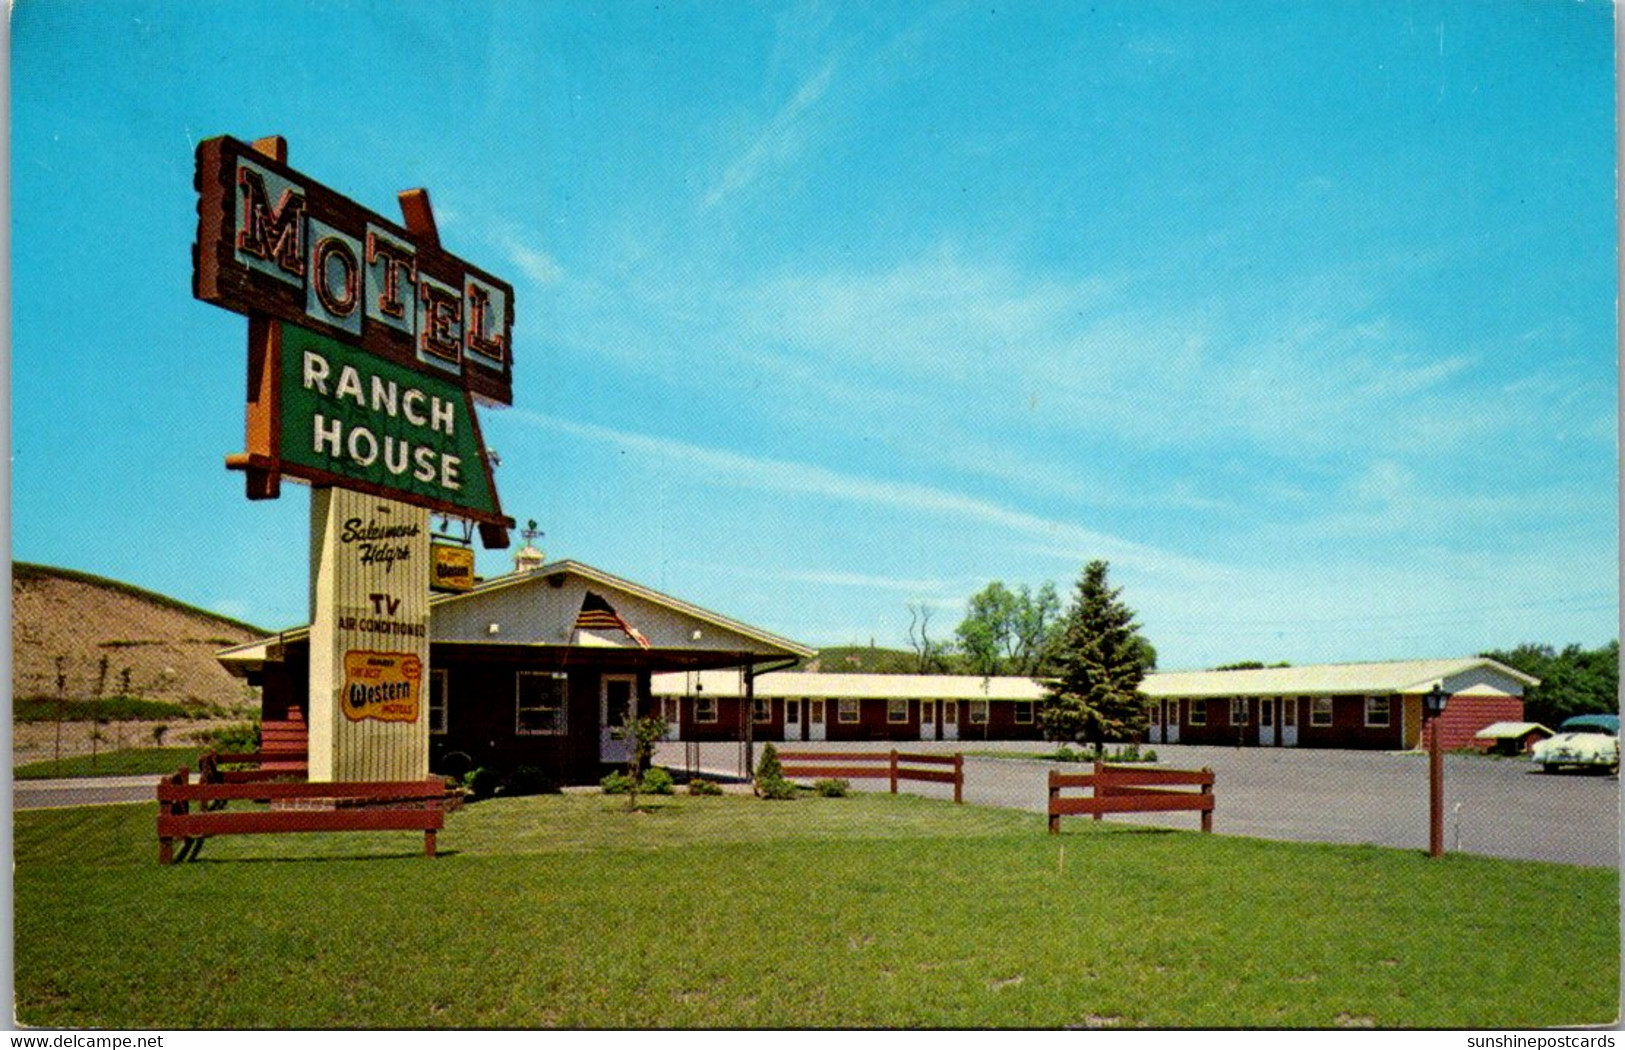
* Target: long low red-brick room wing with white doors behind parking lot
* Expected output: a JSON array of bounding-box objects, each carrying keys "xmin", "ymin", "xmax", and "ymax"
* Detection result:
[{"xmin": 653, "ymin": 657, "xmax": 1539, "ymax": 751}]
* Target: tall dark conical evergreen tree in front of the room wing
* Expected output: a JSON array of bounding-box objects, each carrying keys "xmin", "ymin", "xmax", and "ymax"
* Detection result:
[{"xmin": 1040, "ymin": 561, "xmax": 1155, "ymax": 751}]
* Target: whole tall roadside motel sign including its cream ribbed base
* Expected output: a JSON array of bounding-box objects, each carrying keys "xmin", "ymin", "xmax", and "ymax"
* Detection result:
[{"xmin": 193, "ymin": 137, "xmax": 514, "ymax": 780}]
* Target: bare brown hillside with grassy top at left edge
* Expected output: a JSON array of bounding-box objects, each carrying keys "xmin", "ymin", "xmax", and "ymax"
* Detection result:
[{"xmin": 11, "ymin": 562, "xmax": 267, "ymax": 712}]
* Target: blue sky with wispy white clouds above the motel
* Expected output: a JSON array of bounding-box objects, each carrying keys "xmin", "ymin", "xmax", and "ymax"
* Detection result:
[{"xmin": 11, "ymin": 0, "xmax": 1619, "ymax": 668}]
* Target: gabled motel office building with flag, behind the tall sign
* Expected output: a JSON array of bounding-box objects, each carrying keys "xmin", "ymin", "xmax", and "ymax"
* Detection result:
[{"xmin": 218, "ymin": 546, "xmax": 814, "ymax": 783}]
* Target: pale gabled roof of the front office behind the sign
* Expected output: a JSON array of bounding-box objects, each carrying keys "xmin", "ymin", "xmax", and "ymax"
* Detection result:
[{"xmin": 216, "ymin": 559, "xmax": 816, "ymax": 670}]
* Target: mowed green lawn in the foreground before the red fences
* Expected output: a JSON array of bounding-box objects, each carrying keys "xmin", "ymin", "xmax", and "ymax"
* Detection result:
[{"xmin": 16, "ymin": 795, "xmax": 1619, "ymax": 1029}]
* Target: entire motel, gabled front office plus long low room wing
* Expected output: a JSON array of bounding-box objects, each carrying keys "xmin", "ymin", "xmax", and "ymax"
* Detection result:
[{"xmin": 218, "ymin": 548, "xmax": 1537, "ymax": 782}]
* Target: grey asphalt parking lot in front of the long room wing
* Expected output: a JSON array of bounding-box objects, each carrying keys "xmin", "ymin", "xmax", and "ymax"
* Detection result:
[{"xmin": 657, "ymin": 741, "xmax": 1620, "ymax": 866}]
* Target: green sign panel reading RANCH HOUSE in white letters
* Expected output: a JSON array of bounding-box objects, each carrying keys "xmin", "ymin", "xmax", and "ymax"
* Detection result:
[{"xmin": 281, "ymin": 323, "xmax": 501, "ymax": 515}]
